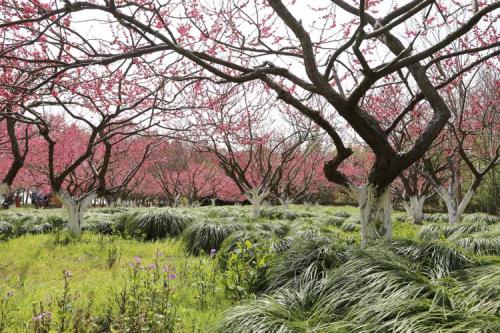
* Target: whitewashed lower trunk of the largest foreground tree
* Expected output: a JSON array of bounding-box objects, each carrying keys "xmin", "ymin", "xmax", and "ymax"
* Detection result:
[{"xmin": 357, "ymin": 184, "xmax": 392, "ymax": 248}]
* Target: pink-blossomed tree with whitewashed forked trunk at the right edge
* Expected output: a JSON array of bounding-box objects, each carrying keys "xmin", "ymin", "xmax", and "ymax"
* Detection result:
[{"xmin": 426, "ymin": 71, "xmax": 500, "ymax": 224}]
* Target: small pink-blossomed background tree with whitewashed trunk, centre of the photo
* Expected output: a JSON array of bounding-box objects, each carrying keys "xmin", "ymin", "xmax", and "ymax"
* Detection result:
[{"xmin": 195, "ymin": 87, "xmax": 308, "ymax": 218}]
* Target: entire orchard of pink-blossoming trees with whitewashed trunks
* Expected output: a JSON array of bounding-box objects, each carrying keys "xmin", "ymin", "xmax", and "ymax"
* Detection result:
[{"xmin": 0, "ymin": 0, "xmax": 500, "ymax": 246}]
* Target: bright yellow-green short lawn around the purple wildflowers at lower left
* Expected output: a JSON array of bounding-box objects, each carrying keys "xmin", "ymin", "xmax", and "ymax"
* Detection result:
[{"xmin": 0, "ymin": 234, "xmax": 230, "ymax": 332}]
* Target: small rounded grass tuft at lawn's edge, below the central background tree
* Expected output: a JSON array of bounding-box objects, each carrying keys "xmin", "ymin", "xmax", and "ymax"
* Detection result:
[{"xmin": 183, "ymin": 220, "xmax": 242, "ymax": 255}]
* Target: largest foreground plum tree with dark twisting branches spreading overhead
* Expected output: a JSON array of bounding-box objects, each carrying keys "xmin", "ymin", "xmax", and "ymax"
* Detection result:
[{"xmin": 0, "ymin": 0, "xmax": 500, "ymax": 246}]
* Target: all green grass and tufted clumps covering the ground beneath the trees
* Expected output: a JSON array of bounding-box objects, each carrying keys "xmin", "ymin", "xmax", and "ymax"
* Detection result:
[{"xmin": 0, "ymin": 205, "xmax": 500, "ymax": 332}]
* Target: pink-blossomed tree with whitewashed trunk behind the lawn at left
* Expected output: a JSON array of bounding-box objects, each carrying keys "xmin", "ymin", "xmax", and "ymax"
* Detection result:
[{"xmin": 17, "ymin": 64, "xmax": 166, "ymax": 236}]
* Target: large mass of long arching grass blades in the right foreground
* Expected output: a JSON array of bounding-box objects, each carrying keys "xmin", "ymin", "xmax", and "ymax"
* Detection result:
[{"xmin": 218, "ymin": 241, "xmax": 500, "ymax": 333}]
